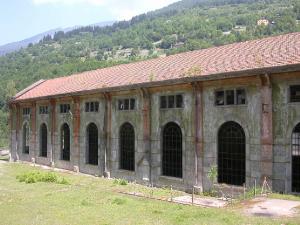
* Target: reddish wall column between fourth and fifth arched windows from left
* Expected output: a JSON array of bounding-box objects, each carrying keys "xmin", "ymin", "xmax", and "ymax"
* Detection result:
[{"xmin": 103, "ymin": 93, "xmax": 112, "ymax": 177}]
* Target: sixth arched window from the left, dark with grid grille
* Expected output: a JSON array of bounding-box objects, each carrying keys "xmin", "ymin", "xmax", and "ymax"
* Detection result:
[{"xmin": 162, "ymin": 122, "xmax": 182, "ymax": 178}]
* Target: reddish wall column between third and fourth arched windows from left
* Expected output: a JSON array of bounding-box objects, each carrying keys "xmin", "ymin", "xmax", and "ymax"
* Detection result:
[{"xmin": 72, "ymin": 97, "xmax": 80, "ymax": 172}]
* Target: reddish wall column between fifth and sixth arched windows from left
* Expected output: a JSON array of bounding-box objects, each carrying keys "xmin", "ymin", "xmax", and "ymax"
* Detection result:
[{"xmin": 141, "ymin": 88, "xmax": 152, "ymax": 183}]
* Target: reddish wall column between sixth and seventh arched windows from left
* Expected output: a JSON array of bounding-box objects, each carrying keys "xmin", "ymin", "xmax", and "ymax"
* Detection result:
[{"xmin": 193, "ymin": 82, "xmax": 203, "ymax": 192}]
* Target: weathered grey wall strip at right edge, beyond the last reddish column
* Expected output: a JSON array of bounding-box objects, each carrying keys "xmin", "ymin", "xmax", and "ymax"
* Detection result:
[{"xmin": 272, "ymin": 72, "xmax": 300, "ymax": 192}]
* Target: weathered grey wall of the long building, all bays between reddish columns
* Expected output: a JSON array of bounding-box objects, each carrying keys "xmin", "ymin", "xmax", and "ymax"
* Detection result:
[{"xmin": 11, "ymin": 73, "xmax": 300, "ymax": 192}]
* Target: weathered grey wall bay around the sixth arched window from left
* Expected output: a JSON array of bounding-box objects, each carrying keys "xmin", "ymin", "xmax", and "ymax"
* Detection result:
[{"xmin": 151, "ymin": 89, "xmax": 195, "ymax": 189}]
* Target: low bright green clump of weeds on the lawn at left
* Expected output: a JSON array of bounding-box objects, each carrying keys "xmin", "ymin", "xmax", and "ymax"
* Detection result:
[{"xmin": 16, "ymin": 171, "xmax": 70, "ymax": 185}]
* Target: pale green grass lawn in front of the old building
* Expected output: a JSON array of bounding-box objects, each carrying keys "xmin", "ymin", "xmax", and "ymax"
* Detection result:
[{"xmin": 0, "ymin": 162, "xmax": 300, "ymax": 225}]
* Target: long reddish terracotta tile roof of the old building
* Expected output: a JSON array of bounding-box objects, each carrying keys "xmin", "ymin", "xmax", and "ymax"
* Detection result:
[{"xmin": 15, "ymin": 33, "xmax": 300, "ymax": 101}]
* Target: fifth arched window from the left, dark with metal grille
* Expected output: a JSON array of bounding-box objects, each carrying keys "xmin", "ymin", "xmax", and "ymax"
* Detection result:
[{"xmin": 120, "ymin": 123, "xmax": 135, "ymax": 171}]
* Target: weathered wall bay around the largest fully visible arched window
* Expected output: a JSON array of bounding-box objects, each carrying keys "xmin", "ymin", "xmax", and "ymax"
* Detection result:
[{"xmin": 203, "ymin": 79, "xmax": 261, "ymax": 190}]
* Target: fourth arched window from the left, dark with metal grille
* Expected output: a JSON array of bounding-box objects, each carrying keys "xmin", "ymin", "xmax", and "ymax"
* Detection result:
[{"xmin": 86, "ymin": 123, "xmax": 98, "ymax": 165}]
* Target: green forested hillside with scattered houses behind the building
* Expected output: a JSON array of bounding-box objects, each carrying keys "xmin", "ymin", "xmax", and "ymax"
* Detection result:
[{"xmin": 0, "ymin": 0, "xmax": 300, "ymax": 145}]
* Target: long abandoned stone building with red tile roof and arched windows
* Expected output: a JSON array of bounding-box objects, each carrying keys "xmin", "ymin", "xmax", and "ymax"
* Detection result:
[{"xmin": 9, "ymin": 33, "xmax": 300, "ymax": 192}]
